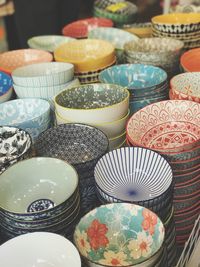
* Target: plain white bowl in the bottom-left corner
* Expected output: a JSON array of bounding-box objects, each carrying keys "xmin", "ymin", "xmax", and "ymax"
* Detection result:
[{"xmin": 0, "ymin": 232, "xmax": 81, "ymax": 267}]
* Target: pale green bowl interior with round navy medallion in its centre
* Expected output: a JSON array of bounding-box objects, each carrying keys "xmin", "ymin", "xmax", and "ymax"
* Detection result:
[{"xmin": 0, "ymin": 158, "xmax": 78, "ymax": 214}]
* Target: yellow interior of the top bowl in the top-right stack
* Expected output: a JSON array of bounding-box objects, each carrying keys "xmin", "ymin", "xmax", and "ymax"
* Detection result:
[{"xmin": 152, "ymin": 13, "xmax": 200, "ymax": 24}]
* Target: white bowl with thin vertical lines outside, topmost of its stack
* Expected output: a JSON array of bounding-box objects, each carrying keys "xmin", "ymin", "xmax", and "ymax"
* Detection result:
[{"xmin": 12, "ymin": 62, "xmax": 74, "ymax": 87}]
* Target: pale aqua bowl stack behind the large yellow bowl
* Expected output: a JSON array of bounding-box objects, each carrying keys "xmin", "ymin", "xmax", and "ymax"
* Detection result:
[{"xmin": 88, "ymin": 27, "xmax": 139, "ymax": 64}]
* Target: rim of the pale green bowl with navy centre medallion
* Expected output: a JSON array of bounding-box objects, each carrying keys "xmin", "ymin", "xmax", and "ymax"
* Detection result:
[{"xmin": 0, "ymin": 157, "xmax": 79, "ymax": 216}]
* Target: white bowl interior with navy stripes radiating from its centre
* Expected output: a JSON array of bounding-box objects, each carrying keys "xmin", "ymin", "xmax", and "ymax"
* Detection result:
[{"xmin": 94, "ymin": 147, "xmax": 173, "ymax": 205}]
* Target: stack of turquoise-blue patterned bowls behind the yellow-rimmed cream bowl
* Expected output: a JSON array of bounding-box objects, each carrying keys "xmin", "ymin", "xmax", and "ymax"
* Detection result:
[{"xmin": 99, "ymin": 64, "xmax": 168, "ymax": 114}]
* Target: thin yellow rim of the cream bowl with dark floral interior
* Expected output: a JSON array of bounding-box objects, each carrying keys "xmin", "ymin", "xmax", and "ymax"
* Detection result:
[{"xmin": 54, "ymin": 83, "xmax": 130, "ymax": 112}]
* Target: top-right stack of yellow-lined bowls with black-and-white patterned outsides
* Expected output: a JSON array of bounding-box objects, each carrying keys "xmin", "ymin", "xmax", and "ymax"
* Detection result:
[{"xmin": 151, "ymin": 13, "xmax": 200, "ymax": 49}]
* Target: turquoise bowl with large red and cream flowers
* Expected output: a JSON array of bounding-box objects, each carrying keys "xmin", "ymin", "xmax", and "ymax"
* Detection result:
[{"xmin": 74, "ymin": 203, "xmax": 165, "ymax": 267}]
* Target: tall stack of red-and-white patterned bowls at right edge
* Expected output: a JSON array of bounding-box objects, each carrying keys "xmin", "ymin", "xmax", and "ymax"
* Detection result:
[{"xmin": 127, "ymin": 100, "xmax": 200, "ymax": 249}]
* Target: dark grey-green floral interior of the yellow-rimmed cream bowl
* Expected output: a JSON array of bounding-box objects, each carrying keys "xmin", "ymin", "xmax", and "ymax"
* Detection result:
[{"xmin": 55, "ymin": 84, "xmax": 129, "ymax": 110}]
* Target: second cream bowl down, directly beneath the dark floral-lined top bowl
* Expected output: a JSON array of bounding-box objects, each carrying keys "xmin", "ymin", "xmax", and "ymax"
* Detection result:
[{"xmin": 55, "ymin": 110, "xmax": 130, "ymax": 138}]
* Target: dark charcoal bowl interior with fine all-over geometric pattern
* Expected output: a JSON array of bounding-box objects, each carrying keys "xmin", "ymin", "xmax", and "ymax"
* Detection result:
[{"xmin": 35, "ymin": 123, "xmax": 108, "ymax": 165}]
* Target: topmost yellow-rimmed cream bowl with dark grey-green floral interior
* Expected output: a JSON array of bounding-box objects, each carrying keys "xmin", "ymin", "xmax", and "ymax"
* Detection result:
[{"xmin": 55, "ymin": 84, "xmax": 129, "ymax": 124}]
